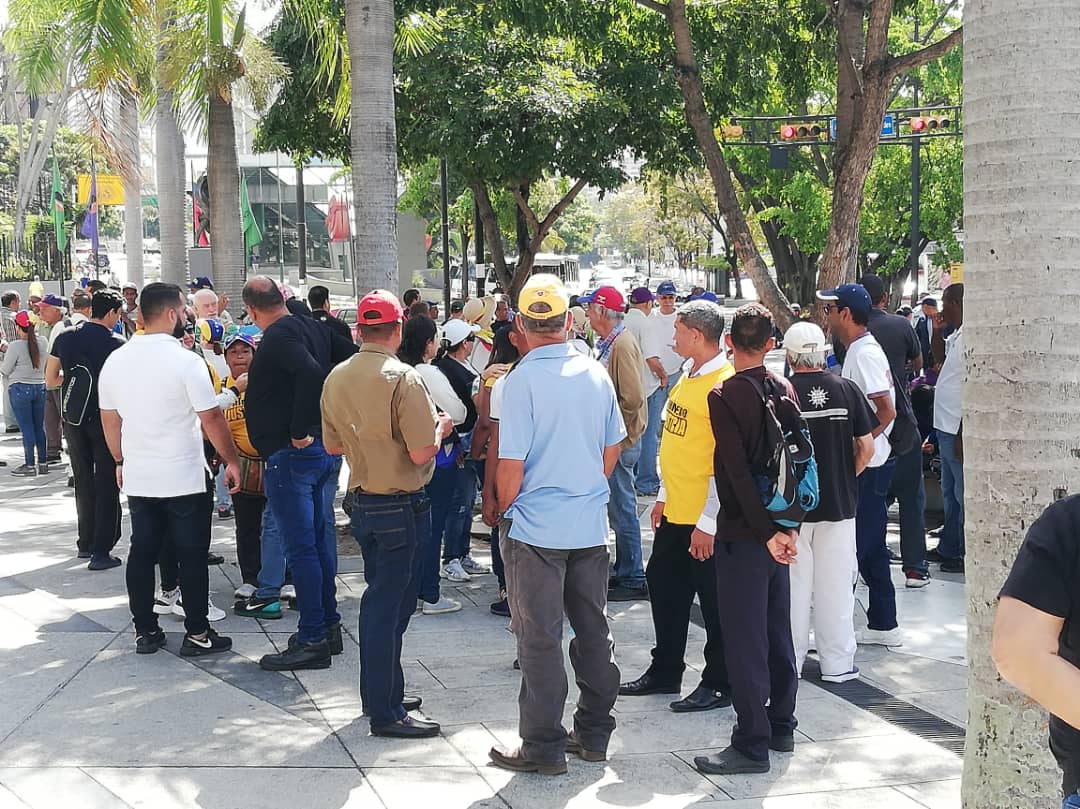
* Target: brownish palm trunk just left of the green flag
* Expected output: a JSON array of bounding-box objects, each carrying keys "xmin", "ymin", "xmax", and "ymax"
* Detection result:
[{"xmin": 206, "ymin": 93, "xmax": 247, "ymax": 300}]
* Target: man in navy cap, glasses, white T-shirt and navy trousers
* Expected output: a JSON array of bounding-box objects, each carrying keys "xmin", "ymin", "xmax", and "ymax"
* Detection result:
[{"xmin": 818, "ymin": 284, "xmax": 903, "ymax": 646}]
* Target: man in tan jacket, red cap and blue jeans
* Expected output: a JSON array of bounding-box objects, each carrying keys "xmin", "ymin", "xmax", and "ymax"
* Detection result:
[{"xmin": 579, "ymin": 286, "xmax": 649, "ymax": 602}]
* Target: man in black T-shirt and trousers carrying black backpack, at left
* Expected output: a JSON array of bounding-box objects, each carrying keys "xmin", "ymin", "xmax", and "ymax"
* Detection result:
[{"xmin": 45, "ymin": 291, "xmax": 124, "ymax": 570}]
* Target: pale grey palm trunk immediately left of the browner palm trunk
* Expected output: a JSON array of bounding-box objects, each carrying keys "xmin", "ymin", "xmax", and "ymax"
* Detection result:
[{"xmin": 154, "ymin": 86, "xmax": 188, "ymax": 285}]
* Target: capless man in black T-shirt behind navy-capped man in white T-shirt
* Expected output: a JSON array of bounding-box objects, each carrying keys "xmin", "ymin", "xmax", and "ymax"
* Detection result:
[{"xmin": 859, "ymin": 275, "xmax": 930, "ymax": 588}]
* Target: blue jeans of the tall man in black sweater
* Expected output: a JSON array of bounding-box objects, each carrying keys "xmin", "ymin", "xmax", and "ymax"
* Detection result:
[{"xmin": 264, "ymin": 439, "xmax": 341, "ymax": 643}]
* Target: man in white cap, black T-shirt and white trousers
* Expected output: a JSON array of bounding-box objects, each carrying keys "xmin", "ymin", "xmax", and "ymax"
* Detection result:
[{"xmin": 784, "ymin": 322, "xmax": 877, "ymax": 683}]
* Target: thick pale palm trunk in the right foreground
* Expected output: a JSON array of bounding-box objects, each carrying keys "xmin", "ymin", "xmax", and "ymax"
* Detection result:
[{"xmin": 963, "ymin": 0, "xmax": 1062, "ymax": 809}]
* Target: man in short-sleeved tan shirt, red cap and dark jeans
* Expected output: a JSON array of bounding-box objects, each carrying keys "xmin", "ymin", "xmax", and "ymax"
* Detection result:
[{"xmin": 322, "ymin": 289, "xmax": 454, "ymax": 739}]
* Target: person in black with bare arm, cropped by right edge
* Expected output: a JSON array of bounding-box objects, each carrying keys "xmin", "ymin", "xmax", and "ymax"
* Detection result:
[{"xmin": 993, "ymin": 496, "xmax": 1080, "ymax": 803}]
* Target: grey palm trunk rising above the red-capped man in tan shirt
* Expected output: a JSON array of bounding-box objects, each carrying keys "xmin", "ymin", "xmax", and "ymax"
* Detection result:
[{"xmin": 345, "ymin": 0, "xmax": 399, "ymax": 294}]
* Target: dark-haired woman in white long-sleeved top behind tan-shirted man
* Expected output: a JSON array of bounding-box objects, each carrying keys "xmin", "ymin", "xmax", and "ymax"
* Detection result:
[{"xmin": 397, "ymin": 318, "xmax": 468, "ymax": 616}]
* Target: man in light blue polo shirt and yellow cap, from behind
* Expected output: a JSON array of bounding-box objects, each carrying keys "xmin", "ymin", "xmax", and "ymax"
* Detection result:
[{"xmin": 489, "ymin": 274, "xmax": 626, "ymax": 776}]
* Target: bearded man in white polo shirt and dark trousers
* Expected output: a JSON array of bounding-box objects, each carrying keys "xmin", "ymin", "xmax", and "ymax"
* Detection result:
[{"xmin": 98, "ymin": 284, "xmax": 240, "ymax": 657}]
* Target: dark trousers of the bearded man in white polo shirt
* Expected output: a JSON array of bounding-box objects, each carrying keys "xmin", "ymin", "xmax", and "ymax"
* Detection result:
[{"xmin": 127, "ymin": 493, "xmax": 214, "ymax": 635}]
